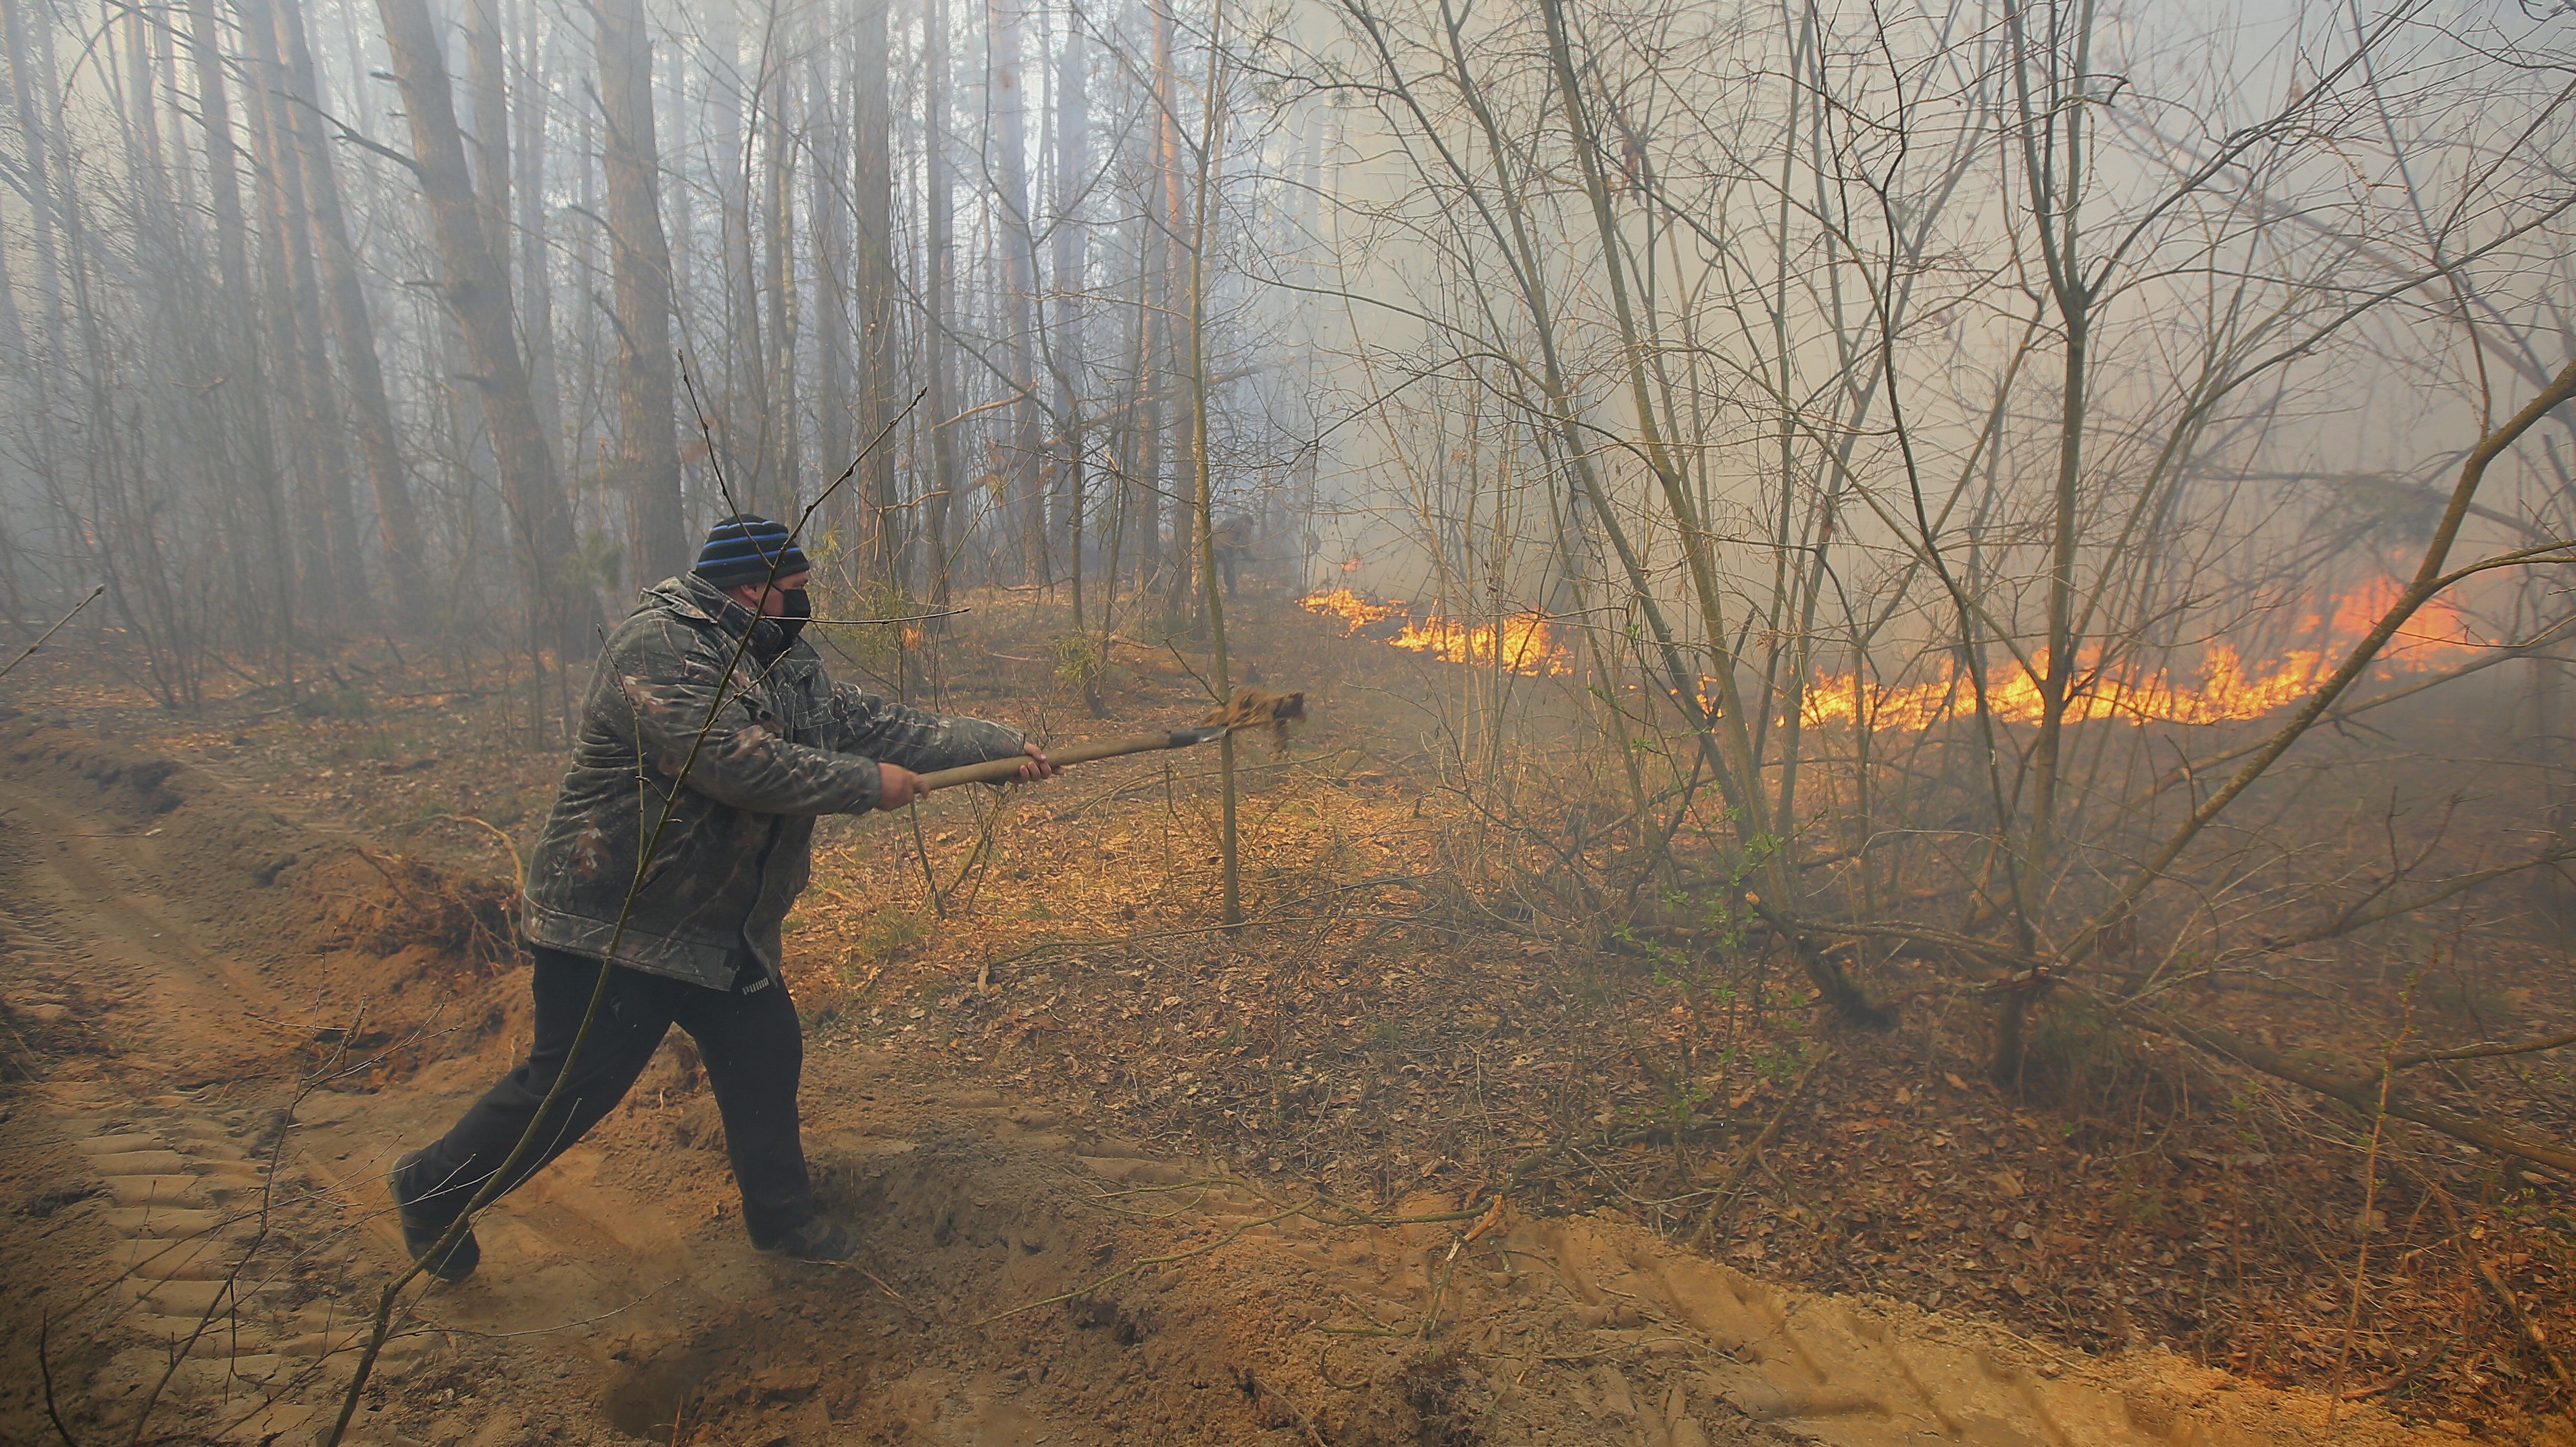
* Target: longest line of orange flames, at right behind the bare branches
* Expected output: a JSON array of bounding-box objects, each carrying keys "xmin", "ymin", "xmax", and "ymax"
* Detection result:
[{"xmin": 1798, "ymin": 579, "xmax": 2481, "ymax": 731}]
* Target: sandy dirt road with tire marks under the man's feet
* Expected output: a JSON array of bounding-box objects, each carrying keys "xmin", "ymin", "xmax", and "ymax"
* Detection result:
[{"xmin": 0, "ymin": 721, "xmax": 2452, "ymax": 1447}]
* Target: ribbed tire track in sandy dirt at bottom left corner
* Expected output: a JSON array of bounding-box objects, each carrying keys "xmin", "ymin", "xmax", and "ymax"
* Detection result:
[{"xmin": 0, "ymin": 780, "xmax": 453, "ymax": 1442}]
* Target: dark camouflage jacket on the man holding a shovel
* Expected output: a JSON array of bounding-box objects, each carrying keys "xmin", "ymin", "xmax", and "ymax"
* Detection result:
[{"xmin": 523, "ymin": 577, "xmax": 1023, "ymax": 989}]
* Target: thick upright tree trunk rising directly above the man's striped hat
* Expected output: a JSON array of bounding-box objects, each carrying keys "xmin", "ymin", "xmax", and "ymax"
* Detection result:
[{"xmin": 595, "ymin": 0, "xmax": 688, "ymax": 587}]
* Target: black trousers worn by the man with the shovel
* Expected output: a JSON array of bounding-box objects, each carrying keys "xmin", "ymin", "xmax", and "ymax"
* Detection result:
[{"xmin": 399, "ymin": 947, "xmax": 814, "ymax": 1246}]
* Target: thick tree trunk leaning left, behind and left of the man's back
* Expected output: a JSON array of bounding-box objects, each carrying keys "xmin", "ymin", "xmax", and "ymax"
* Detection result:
[{"xmin": 376, "ymin": 0, "xmax": 598, "ymax": 659}]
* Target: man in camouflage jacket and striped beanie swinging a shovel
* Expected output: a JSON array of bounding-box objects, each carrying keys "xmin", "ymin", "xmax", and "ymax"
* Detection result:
[{"xmin": 389, "ymin": 513, "xmax": 1056, "ymax": 1282}]
